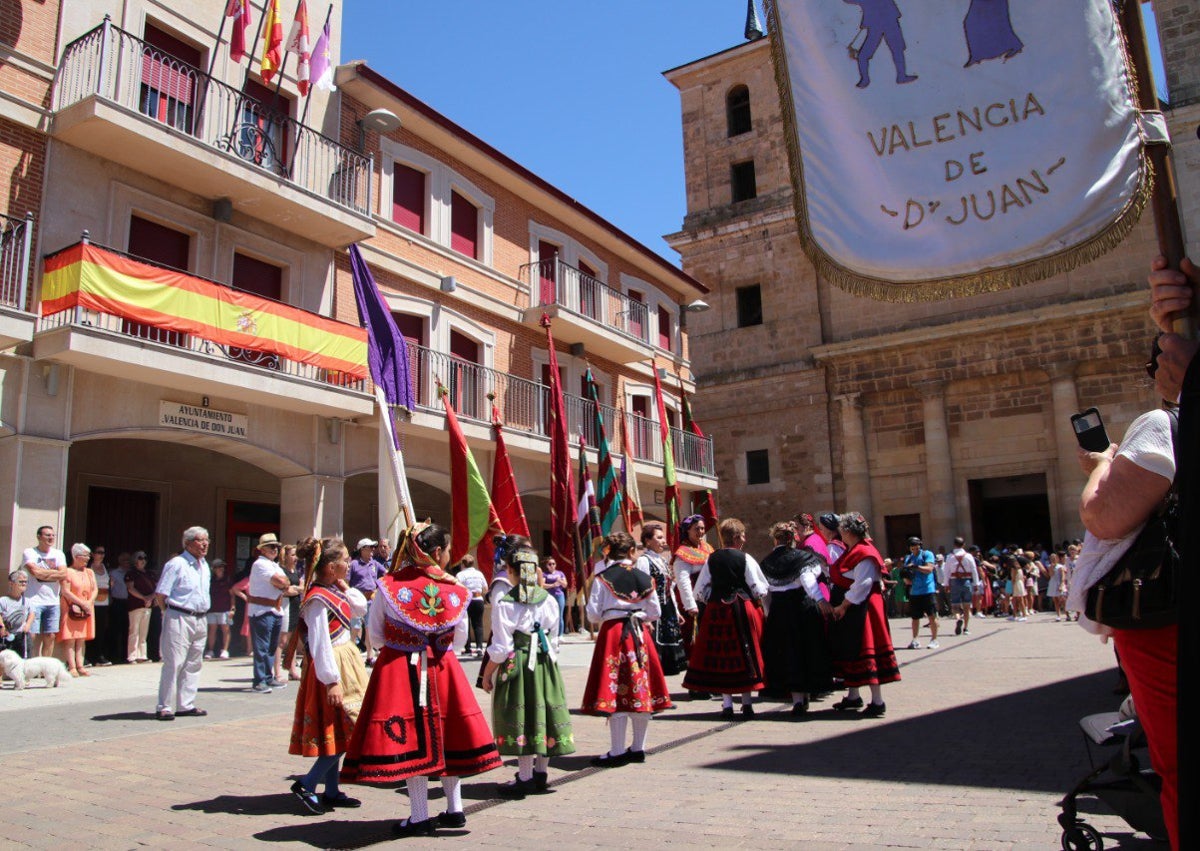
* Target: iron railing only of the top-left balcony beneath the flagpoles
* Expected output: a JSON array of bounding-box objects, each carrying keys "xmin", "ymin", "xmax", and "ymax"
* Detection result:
[{"xmin": 54, "ymin": 17, "xmax": 372, "ymax": 215}]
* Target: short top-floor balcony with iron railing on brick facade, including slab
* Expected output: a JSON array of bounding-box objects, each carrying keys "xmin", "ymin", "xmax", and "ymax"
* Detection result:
[{"xmin": 520, "ymin": 254, "xmax": 652, "ymax": 364}]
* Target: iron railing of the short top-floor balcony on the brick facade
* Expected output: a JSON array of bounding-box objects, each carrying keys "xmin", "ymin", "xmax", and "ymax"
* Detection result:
[{"xmin": 521, "ymin": 254, "xmax": 650, "ymax": 346}]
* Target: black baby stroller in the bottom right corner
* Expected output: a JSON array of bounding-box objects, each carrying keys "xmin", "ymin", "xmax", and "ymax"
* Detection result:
[{"xmin": 1058, "ymin": 712, "xmax": 1166, "ymax": 851}]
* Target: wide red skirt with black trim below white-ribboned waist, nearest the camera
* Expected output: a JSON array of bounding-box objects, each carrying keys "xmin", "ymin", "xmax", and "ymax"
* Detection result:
[{"xmin": 341, "ymin": 647, "xmax": 500, "ymax": 785}]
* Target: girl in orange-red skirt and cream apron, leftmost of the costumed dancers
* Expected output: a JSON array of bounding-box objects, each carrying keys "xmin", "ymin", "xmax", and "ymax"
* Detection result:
[{"xmin": 288, "ymin": 538, "xmax": 367, "ymax": 815}]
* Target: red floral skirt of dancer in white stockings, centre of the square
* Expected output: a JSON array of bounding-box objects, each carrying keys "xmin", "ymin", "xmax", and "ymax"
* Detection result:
[{"xmin": 583, "ymin": 618, "xmax": 673, "ymax": 715}]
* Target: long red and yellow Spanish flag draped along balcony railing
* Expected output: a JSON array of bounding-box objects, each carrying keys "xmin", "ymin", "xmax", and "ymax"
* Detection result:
[{"xmin": 42, "ymin": 242, "xmax": 367, "ymax": 380}]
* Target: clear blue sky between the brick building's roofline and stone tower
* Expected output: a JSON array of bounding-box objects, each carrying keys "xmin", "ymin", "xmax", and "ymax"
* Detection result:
[{"xmin": 338, "ymin": 0, "xmax": 762, "ymax": 263}]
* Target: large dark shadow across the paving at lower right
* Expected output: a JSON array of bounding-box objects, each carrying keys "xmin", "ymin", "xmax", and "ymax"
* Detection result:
[{"xmin": 706, "ymin": 666, "xmax": 1114, "ymax": 793}]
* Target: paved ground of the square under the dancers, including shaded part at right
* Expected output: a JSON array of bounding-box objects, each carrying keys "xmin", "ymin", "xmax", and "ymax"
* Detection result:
[{"xmin": 0, "ymin": 615, "xmax": 1164, "ymax": 851}]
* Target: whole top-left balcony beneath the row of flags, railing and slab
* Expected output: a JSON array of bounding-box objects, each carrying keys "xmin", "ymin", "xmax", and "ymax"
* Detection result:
[{"xmin": 50, "ymin": 17, "xmax": 374, "ymax": 246}]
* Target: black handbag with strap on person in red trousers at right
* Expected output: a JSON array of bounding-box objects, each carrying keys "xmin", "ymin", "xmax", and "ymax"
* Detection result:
[{"xmin": 1086, "ymin": 410, "xmax": 1180, "ymax": 629}]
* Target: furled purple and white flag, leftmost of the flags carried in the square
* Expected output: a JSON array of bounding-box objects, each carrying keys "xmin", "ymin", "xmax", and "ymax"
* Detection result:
[{"xmin": 350, "ymin": 245, "xmax": 415, "ymax": 537}]
